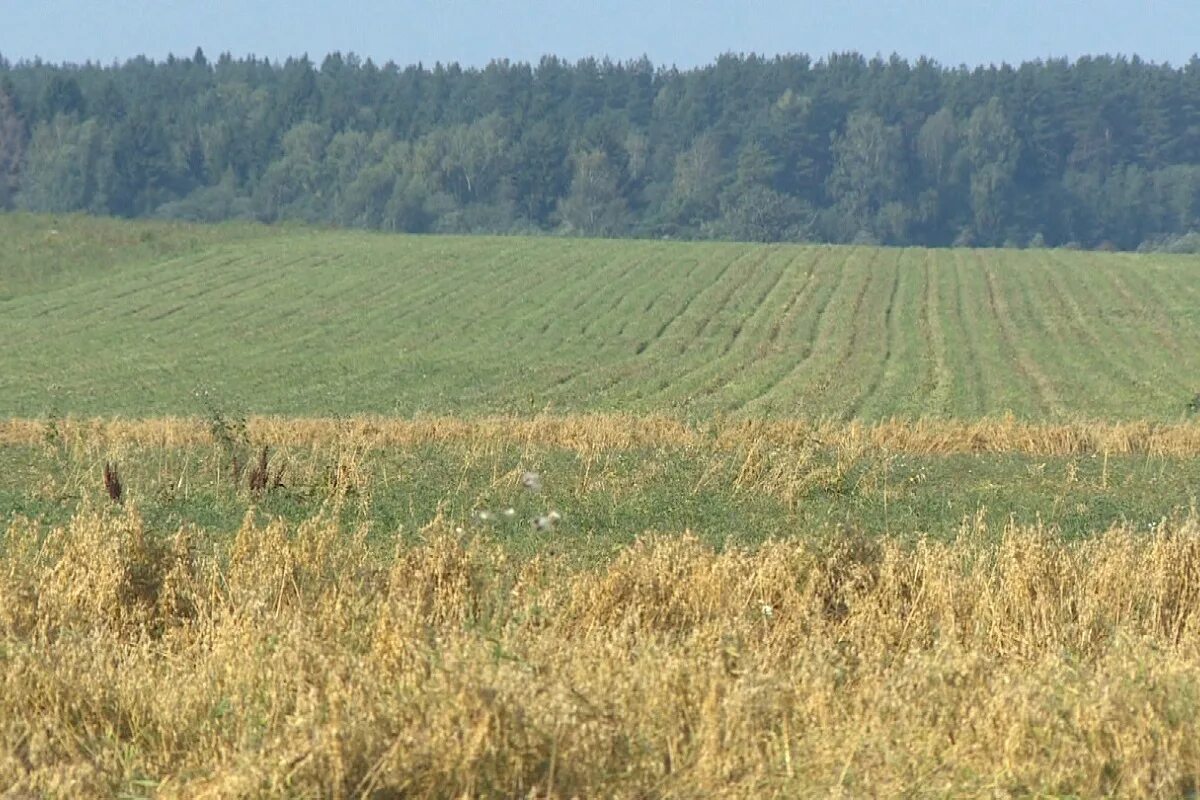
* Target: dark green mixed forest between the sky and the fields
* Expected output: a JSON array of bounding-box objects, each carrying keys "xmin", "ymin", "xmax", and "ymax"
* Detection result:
[{"xmin": 0, "ymin": 50, "xmax": 1200, "ymax": 249}]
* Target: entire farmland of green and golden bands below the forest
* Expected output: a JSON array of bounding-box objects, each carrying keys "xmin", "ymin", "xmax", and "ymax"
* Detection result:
[{"xmin": 7, "ymin": 215, "xmax": 1200, "ymax": 798}]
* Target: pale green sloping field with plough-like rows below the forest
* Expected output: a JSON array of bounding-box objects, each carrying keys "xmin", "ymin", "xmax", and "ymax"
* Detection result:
[{"xmin": 0, "ymin": 216, "xmax": 1200, "ymax": 420}]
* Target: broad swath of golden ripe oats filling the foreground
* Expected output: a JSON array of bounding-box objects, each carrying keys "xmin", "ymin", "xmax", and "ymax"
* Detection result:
[{"xmin": 0, "ymin": 504, "xmax": 1200, "ymax": 798}]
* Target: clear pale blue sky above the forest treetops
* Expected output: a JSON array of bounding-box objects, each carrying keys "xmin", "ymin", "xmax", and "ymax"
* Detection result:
[{"xmin": 0, "ymin": 0, "xmax": 1200, "ymax": 68}]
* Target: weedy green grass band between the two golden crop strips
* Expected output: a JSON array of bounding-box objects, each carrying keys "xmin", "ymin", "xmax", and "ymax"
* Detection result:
[{"xmin": 7, "ymin": 443, "xmax": 1200, "ymax": 560}]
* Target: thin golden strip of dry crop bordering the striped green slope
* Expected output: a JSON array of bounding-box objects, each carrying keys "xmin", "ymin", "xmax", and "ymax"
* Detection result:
[{"xmin": 11, "ymin": 414, "xmax": 1200, "ymax": 457}]
